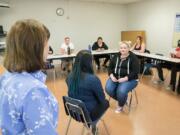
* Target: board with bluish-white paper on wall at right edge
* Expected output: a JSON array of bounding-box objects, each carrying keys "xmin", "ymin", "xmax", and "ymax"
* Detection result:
[{"xmin": 173, "ymin": 13, "xmax": 180, "ymax": 47}]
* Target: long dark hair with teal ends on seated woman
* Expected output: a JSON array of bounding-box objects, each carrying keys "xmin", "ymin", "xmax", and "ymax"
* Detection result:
[{"xmin": 69, "ymin": 50, "xmax": 93, "ymax": 94}]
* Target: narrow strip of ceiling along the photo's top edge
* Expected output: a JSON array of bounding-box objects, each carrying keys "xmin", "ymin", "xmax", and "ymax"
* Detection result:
[{"xmin": 71, "ymin": 0, "xmax": 147, "ymax": 4}]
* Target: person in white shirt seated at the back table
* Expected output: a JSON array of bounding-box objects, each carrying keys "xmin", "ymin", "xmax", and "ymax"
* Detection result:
[{"xmin": 60, "ymin": 37, "xmax": 74, "ymax": 72}]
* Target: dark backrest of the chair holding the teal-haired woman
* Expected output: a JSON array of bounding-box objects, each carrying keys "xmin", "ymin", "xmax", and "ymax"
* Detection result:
[{"xmin": 63, "ymin": 96, "xmax": 92, "ymax": 128}]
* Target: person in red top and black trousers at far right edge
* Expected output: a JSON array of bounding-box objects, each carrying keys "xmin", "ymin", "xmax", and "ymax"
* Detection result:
[{"xmin": 156, "ymin": 40, "xmax": 180, "ymax": 87}]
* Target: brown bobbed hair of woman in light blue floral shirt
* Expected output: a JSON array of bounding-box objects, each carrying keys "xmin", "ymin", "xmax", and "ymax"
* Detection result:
[{"xmin": 4, "ymin": 19, "xmax": 49, "ymax": 72}]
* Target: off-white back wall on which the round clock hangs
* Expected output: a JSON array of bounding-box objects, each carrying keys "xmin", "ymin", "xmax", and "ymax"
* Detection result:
[{"xmin": 0, "ymin": 0, "xmax": 127, "ymax": 53}]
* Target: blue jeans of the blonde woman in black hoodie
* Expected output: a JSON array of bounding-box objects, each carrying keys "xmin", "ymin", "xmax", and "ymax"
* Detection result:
[{"xmin": 105, "ymin": 78, "xmax": 138, "ymax": 107}]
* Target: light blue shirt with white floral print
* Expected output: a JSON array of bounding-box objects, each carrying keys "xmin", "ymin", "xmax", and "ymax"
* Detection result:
[{"xmin": 0, "ymin": 71, "xmax": 58, "ymax": 135}]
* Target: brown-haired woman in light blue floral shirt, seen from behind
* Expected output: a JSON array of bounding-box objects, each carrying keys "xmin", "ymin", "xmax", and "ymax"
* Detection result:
[{"xmin": 0, "ymin": 19, "xmax": 59, "ymax": 135}]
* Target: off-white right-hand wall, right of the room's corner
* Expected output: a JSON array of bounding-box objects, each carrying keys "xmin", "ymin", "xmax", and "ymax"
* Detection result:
[{"xmin": 127, "ymin": 0, "xmax": 180, "ymax": 55}]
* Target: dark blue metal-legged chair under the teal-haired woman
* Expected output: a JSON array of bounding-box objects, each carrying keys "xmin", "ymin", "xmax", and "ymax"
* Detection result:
[{"xmin": 63, "ymin": 96, "xmax": 109, "ymax": 135}]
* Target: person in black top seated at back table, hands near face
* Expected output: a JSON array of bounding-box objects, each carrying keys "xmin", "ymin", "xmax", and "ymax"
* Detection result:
[{"xmin": 92, "ymin": 37, "xmax": 110, "ymax": 69}]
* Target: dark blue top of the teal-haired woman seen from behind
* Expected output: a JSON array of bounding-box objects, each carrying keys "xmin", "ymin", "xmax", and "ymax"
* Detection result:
[{"xmin": 67, "ymin": 73, "xmax": 109, "ymax": 120}]
